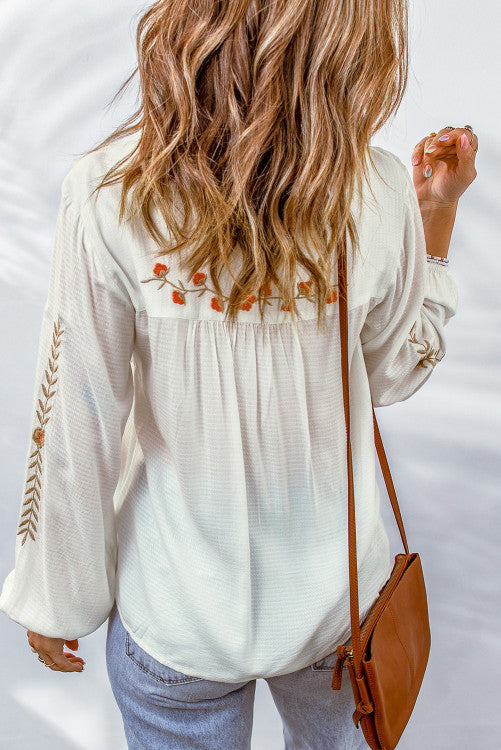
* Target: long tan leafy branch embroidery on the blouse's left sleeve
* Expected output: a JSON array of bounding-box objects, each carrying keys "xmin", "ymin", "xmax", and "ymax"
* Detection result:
[{"xmin": 16, "ymin": 319, "xmax": 64, "ymax": 544}]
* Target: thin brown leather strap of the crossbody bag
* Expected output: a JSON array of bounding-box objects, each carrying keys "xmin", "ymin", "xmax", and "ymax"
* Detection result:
[{"xmin": 338, "ymin": 240, "xmax": 409, "ymax": 678}]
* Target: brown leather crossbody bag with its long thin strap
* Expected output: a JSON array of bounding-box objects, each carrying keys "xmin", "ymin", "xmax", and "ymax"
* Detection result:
[{"xmin": 332, "ymin": 251, "xmax": 431, "ymax": 750}]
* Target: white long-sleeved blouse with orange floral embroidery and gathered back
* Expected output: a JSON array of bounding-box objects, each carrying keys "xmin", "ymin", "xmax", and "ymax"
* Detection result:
[{"xmin": 0, "ymin": 136, "xmax": 457, "ymax": 682}]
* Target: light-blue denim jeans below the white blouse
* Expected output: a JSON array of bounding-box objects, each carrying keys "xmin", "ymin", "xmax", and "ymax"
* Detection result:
[{"xmin": 106, "ymin": 603, "xmax": 367, "ymax": 750}]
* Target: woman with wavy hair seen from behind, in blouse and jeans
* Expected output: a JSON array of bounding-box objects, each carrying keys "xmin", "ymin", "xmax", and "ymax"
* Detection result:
[{"xmin": 0, "ymin": 0, "xmax": 478, "ymax": 750}]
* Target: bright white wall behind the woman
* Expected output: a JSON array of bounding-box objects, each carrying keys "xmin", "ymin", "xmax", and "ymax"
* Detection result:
[{"xmin": 0, "ymin": 0, "xmax": 501, "ymax": 750}]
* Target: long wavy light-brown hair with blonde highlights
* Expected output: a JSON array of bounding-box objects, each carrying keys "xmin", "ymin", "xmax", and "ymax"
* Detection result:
[{"xmin": 81, "ymin": 0, "xmax": 408, "ymax": 330}]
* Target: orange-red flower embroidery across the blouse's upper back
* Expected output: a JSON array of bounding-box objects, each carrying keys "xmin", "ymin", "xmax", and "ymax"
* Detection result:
[{"xmin": 141, "ymin": 263, "xmax": 337, "ymax": 312}]
